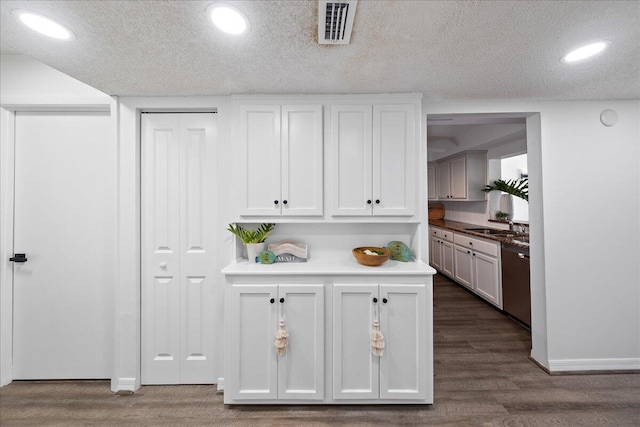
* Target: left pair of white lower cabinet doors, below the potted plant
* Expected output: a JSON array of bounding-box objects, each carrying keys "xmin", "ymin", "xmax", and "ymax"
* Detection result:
[{"xmin": 225, "ymin": 284, "xmax": 324, "ymax": 402}]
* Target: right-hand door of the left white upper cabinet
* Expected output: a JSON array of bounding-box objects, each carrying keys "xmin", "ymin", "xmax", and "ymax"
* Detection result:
[{"xmin": 281, "ymin": 105, "xmax": 324, "ymax": 216}]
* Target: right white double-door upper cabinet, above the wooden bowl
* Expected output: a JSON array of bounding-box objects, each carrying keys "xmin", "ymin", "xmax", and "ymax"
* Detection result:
[{"xmin": 330, "ymin": 104, "xmax": 418, "ymax": 216}]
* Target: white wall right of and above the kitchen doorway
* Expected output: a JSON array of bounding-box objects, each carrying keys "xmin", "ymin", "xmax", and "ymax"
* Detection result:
[{"xmin": 423, "ymin": 100, "xmax": 640, "ymax": 371}]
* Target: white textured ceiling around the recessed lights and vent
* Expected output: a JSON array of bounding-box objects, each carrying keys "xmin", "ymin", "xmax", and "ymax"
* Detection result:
[{"xmin": 0, "ymin": 0, "xmax": 640, "ymax": 100}]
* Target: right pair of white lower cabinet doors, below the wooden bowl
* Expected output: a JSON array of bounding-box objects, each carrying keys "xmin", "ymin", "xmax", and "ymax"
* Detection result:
[{"xmin": 333, "ymin": 284, "xmax": 428, "ymax": 400}]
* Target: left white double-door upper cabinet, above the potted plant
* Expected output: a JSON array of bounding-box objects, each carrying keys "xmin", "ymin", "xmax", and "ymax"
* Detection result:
[{"xmin": 237, "ymin": 104, "xmax": 323, "ymax": 216}]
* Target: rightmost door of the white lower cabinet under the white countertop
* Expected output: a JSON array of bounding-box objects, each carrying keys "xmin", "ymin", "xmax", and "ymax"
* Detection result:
[{"xmin": 379, "ymin": 284, "xmax": 429, "ymax": 399}]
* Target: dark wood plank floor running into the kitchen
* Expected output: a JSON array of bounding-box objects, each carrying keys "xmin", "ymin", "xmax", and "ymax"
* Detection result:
[{"xmin": 0, "ymin": 275, "xmax": 640, "ymax": 426}]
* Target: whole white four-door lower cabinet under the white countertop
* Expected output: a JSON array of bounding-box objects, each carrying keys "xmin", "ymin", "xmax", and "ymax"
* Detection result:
[{"xmin": 224, "ymin": 276, "xmax": 433, "ymax": 404}]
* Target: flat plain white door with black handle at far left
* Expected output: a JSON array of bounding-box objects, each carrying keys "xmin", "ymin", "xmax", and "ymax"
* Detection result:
[{"xmin": 13, "ymin": 112, "xmax": 116, "ymax": 379}]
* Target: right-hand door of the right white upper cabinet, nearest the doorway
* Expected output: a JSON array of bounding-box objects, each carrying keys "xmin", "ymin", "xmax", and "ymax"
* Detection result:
[{"xmin": 372, "ymin": 104, "xmax": 416, "ymax": 216}]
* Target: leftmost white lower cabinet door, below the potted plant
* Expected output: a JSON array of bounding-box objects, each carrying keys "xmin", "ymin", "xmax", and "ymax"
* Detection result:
[{"xmin": 225, "ymin": 285, "xmax": 278, "ymax": 400}]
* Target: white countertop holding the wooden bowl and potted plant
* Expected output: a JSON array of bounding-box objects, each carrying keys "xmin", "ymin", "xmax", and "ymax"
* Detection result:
[{"xmin": 222, "ymin": 255, "xmax": 436, "ymax": 276}]
